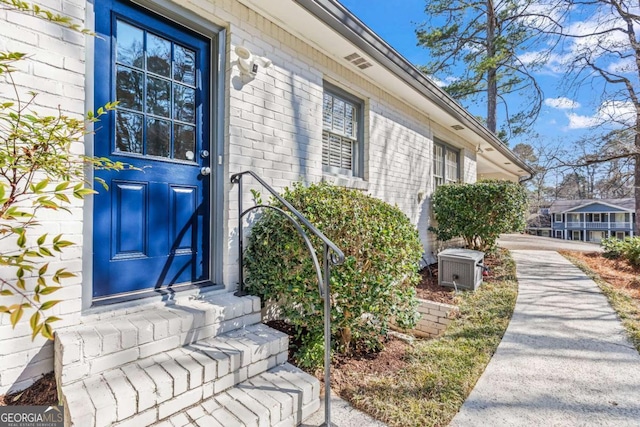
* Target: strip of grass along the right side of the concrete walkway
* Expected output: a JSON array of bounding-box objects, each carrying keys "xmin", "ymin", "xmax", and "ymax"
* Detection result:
[{"xmin": 561, "ymin": 253, "xmax": 640, "ymax": 353}]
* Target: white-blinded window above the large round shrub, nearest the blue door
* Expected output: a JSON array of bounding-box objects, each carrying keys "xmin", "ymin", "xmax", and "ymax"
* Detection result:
[{"xmin": 322, "ymin": 82, "xmax": 363, "ymax": 177}]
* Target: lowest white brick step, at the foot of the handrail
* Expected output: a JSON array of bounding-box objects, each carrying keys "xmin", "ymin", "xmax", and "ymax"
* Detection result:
[{"xmin": 149, "ymin": 363, "xmax": 320, "ymax": 427}]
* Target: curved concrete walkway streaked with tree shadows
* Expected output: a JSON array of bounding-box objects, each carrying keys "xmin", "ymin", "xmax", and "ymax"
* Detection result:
[{"xmin": 450, "ymin": 250, "xmax": 640, "ymax": 427}]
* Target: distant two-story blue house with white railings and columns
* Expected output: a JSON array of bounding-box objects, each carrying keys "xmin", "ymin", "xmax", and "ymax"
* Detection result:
[{"xmin": 549, "ymin": 198, "xmax": 637, "ymax": 243}]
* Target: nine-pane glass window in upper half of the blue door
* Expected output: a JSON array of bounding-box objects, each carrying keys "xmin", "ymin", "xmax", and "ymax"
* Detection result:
[{"xmin": 114, "ymin": 20, "xmax": 201, "ymax": 161}]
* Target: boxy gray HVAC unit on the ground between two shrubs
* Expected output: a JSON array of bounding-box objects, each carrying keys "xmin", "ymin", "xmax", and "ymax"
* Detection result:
[{"xmin": 438, "ymin": 249, "xmax": 484, "ymax": 291}]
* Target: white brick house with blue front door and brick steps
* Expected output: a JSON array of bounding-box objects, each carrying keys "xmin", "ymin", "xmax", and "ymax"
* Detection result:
[{"xmin": 0, "ymin": 0, "xmax": 531, "ymax": 427}]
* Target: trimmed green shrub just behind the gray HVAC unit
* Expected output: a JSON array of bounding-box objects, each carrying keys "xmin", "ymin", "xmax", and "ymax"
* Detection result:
[{"xmin": 429, "ymin": 180, "xmax": 527, "ymax": 251}]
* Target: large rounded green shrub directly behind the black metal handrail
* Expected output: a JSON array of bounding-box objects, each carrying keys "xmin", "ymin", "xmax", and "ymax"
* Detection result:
[{"xmin": 245, "ymin": 183, "xmax": 422, "ymax": 367}]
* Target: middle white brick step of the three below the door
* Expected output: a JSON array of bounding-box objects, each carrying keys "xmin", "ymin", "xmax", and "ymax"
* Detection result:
[{"xmin": 59, "ymin": 324, "xmax": 289, "ymax": 427}]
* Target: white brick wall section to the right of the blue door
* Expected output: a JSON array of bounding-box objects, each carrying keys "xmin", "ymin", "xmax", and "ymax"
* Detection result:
[{"xmin": 210, "ymin": 3, "xmax": 476, "ymax": 287}]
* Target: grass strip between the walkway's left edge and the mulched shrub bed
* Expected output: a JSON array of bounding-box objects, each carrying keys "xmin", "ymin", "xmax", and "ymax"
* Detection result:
[{"xmin": 347, "ymin": 252, "xmax": 517, "ymax": 427}]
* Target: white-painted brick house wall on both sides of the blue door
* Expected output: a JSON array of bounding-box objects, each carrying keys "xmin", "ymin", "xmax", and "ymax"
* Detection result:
[{"xmin": 0, "ymin": 0, "xmax": 476, "ymax": 393}]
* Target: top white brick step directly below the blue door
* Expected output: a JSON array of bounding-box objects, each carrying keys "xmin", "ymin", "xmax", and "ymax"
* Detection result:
[{"xmin": 54, "ymin": 294, "xmax": 261, "ymax": 386}]
